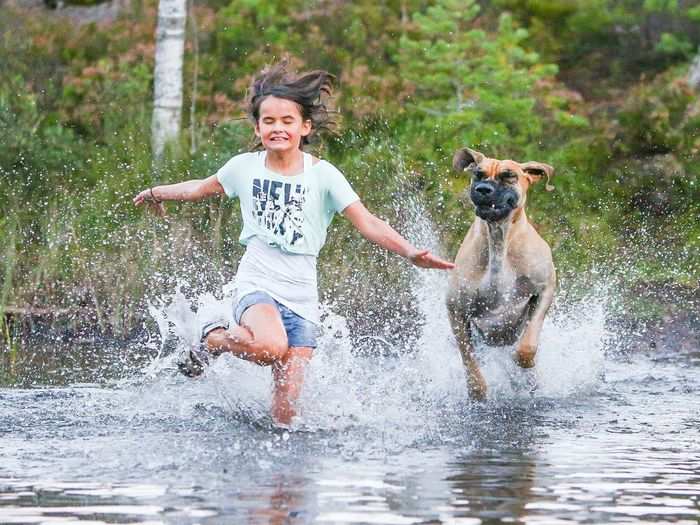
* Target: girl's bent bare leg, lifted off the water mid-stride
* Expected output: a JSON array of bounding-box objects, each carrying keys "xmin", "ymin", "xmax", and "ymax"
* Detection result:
[{"xmin": 205, "ymin": 303, "xmax": 288, "ymax": 365}]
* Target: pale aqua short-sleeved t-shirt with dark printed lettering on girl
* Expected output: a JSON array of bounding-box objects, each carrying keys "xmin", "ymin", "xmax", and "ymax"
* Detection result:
[{"xmin": 216, "ymin": 151, "xmax": 359, "ymax": 256}]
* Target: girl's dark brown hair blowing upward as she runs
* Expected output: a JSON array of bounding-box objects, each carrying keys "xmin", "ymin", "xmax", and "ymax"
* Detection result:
[{"xmin": 247, "ymin": 60, "xmax": 336, "ymax": 149}]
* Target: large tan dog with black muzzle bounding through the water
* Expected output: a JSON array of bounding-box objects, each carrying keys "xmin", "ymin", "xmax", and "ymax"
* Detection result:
[{"xmin": 447, "ymin": 148, "xmax": 556, "ymax": 399}]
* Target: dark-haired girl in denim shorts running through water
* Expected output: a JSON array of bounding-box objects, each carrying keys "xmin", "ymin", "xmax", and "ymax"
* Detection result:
[{"xmin": 134, "ymin": 63, "xmax": 454, "ymax": 426}]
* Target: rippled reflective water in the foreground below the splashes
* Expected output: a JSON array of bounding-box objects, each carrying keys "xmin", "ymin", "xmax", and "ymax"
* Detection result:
[{"xmin": 0, "ymin": 342, "xmax": 700, "ymax": 524}]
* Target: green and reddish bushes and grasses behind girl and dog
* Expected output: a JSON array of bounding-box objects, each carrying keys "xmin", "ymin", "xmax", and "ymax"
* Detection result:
[{"xmin": 0, "ymin": 0, "xmax": 700, "ymax": 337}]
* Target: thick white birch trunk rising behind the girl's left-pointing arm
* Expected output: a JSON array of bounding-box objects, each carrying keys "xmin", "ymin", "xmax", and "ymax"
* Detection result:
[{"xmin": 151, "ymin": 0, "xmax": 187, "ymax": 161}]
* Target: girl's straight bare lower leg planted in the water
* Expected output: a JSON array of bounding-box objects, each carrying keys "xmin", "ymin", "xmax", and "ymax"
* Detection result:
[{"xmin": 272, "ymin": 346, "xmax": 313, "ymax": 425}]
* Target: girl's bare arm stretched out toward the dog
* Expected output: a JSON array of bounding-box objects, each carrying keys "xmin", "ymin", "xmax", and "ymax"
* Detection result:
[{"xmin": 343, "ymin": 201, "xmax": 455, "ymax": 270}]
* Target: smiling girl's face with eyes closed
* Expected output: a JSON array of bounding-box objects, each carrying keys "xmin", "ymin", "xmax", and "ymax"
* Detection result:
[{"xmin": 255, "ymin": 96, "xmax": 311, "ymax": 153}]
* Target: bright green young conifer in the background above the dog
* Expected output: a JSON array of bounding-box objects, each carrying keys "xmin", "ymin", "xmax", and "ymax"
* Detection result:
[{"xmin": 399, "ymin": 0, "xmax": 556, "ymax": 157}]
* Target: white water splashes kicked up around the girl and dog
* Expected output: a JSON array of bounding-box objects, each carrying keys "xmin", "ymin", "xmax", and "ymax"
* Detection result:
[{"xmin": 137, "ymin": 186, "xmax": 609, "ymax": 444}]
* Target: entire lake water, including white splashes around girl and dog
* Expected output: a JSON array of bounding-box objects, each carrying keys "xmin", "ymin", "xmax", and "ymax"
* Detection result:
[{"xmin": 0, "ymin": 268, "xmax": 700, "ymax": 524}]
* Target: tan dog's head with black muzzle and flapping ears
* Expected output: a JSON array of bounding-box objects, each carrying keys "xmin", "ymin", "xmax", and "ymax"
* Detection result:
[{"xmin": 452, "ymin": 148, "xmax": 554, "ymax": 222}]
